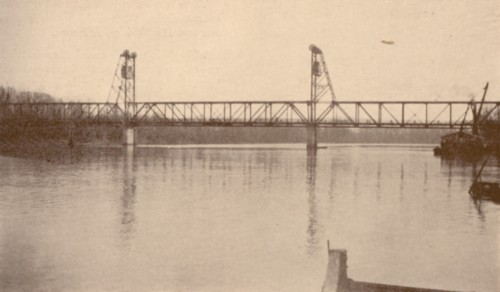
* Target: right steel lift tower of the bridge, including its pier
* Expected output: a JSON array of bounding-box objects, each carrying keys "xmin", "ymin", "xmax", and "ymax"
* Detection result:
[{"xmin": 307, "ymin": 45, "xmax": 336, "ymax": 150}]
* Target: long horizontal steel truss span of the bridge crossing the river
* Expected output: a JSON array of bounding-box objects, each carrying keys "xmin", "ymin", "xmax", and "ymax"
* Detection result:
[{"xmin": 0, "ymin": 101, "xmax": 500, "ymax": 128}]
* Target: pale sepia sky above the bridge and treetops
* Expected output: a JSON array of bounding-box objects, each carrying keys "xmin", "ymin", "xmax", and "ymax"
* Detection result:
[{"xmin": 0, "ymin": 0, "xmax": 500, "ymax": 102}]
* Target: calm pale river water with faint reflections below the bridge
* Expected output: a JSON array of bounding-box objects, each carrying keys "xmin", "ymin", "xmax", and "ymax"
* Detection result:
[{"xmin": 0, "ymin": 145, "xmax": 500, "ymax": 291}]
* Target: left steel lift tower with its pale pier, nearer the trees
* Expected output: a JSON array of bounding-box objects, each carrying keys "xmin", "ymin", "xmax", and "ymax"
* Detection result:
[{"xmin": 108, "ymin": 50, "xmax": 137, "ymax": 145}]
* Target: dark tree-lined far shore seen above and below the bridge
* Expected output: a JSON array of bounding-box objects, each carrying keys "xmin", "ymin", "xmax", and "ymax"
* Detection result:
[{"xmin": 0, "ymin": 86, "xmax": 500, "ymax": 158}]
